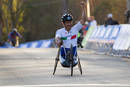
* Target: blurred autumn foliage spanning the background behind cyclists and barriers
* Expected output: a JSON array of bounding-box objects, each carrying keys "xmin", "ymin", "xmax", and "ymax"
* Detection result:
[{"xmin": 0, "ymin": 0, "xmax": 126, "ymax": 42}]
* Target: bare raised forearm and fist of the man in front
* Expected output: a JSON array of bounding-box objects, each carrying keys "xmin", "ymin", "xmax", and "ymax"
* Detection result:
[{"xmin": 80, "ymin": 1, "xmax": 87, "ymax": 24}]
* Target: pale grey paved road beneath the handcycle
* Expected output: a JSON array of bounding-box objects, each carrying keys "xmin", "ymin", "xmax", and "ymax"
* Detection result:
[{"xmin": 0, "ymin": 48, "xmax": 130, "ymax": 87}]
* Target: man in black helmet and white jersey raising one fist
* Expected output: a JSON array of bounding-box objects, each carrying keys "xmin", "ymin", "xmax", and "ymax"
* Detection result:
[{"xmin": 55, "ymin": 2, "xmax": 86, "ymax": 67}]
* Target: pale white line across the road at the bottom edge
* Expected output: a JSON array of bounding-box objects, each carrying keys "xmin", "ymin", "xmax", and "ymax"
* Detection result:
[{"xmin": 2, "ymin": 84, "xmax": 130, "ymax": 87}]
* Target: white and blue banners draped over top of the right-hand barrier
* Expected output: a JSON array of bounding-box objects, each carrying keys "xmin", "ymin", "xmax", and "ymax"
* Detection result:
[{"xmin": 82, "ymin": 24, "xmax": 130, "ymax": 50}]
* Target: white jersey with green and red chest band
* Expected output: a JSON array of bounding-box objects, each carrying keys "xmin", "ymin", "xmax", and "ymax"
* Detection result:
[{"xmin": 55, "ymin": 22, "xmax": 83, "ymax": 48}]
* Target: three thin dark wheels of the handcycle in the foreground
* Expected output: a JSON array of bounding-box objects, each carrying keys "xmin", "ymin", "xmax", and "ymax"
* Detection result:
[{"xmin": 53, "ymin": 45, "xmax": 82, "ymax": 76}]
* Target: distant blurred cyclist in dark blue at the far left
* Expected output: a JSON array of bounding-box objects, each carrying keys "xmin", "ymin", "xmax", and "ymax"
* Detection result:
[{"xmin": 8, "ymin": 28, "xmax": 21, "ymax": 47}]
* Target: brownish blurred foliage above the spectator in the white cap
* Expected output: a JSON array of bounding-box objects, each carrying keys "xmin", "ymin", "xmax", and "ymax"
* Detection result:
[{"xmin": 92, "ymin": 0, "xmax": 126, "ymax": 24}]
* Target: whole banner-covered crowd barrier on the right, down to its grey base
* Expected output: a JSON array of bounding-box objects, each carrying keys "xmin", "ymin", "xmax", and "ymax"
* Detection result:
[{"xmin": 82, "ymin": 24, "xmax": 130, "ymax": 55}]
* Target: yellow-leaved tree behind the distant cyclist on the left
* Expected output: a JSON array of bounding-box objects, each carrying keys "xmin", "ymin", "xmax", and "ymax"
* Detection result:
[{"xmin": 0, "ymin": 0, "xmax": 24, "ymax": 41}]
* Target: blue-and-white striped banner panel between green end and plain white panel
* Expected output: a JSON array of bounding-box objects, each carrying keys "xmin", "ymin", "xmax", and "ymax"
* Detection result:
[{"xmin": 88, "ymin": 25, "xmax": 121, "ymax": 43}]
